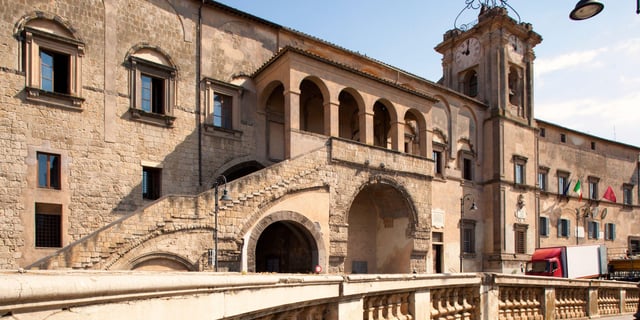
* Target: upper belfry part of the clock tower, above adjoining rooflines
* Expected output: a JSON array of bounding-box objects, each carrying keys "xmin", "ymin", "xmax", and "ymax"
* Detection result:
[{"xmin": 435, "ymin": 6, "xmax": 542, "ymax": 125}]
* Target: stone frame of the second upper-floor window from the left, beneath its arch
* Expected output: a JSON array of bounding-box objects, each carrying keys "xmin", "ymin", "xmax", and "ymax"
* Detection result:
[{"xmin": 129, "ymin": 55, "xmax": 176, "ymax": 127}]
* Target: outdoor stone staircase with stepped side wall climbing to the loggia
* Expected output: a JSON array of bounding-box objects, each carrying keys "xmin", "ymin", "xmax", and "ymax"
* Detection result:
[{"xmin": 26, "ymin": 144, "xmax": 330, "ymax": 270}]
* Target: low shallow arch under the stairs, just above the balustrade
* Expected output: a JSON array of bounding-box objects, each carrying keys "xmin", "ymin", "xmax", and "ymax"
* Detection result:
[{"xmin": 128, "ymin": 252, "xmax": 198, "ymax": 271}]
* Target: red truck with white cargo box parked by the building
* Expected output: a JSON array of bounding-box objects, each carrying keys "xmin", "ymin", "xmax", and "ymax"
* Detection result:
[{"xmin": 525, "ymin": 245, "xmax": 607, "ymax": 279}]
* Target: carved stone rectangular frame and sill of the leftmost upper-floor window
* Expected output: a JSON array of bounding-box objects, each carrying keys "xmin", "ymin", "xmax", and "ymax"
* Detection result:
[{"xmin": 22, "ymin": 25, "xmax": 84, "ymax": 111}]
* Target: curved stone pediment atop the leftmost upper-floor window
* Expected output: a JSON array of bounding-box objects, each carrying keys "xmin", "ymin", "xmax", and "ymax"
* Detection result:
[{"xmin": 13, "ymin": 11, "xmax": 83, "ymax": 42}]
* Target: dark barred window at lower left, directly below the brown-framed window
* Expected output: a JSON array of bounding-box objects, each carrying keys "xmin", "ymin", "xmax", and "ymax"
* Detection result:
[{"xmin": 35, "ymin": 203, "xmax": 62, "ymax": 248}]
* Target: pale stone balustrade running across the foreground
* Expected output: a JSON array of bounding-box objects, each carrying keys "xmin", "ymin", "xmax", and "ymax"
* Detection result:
[{"xmin": 0, "ymin": 271, "xmax": 639, "ymax": 320}]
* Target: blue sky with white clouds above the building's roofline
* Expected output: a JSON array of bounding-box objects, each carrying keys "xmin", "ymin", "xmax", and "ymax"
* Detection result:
[{"xmin": 219, "ymin": 0, "xmax": 640, "ymax": 147}]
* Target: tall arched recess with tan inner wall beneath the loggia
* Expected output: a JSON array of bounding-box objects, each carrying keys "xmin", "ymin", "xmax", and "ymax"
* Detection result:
[{"xmin": 344, "ymin": 176, "xmax": 417, "ymax": 273}]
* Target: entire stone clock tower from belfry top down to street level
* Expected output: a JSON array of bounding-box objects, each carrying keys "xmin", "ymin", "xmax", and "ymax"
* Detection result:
[{"xmin": 435, "ymin": 5, "xmax": 542, "ymax": 273}]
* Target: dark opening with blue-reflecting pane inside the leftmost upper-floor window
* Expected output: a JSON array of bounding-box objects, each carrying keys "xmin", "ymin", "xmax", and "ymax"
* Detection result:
[{"xmin": 40, "ymin": 49, "xmax": 69, "ymax": 94}]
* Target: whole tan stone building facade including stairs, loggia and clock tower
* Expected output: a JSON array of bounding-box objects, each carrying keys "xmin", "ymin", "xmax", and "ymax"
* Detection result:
[{"xmin": 0, "ymin": 0, "xmax": 640, "ymax": 273}]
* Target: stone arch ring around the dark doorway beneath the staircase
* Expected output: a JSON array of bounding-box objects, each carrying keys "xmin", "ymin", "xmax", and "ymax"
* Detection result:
[{"xmin": 247, "ymin": 211, "xmax": 327, "ymax": 272}]
